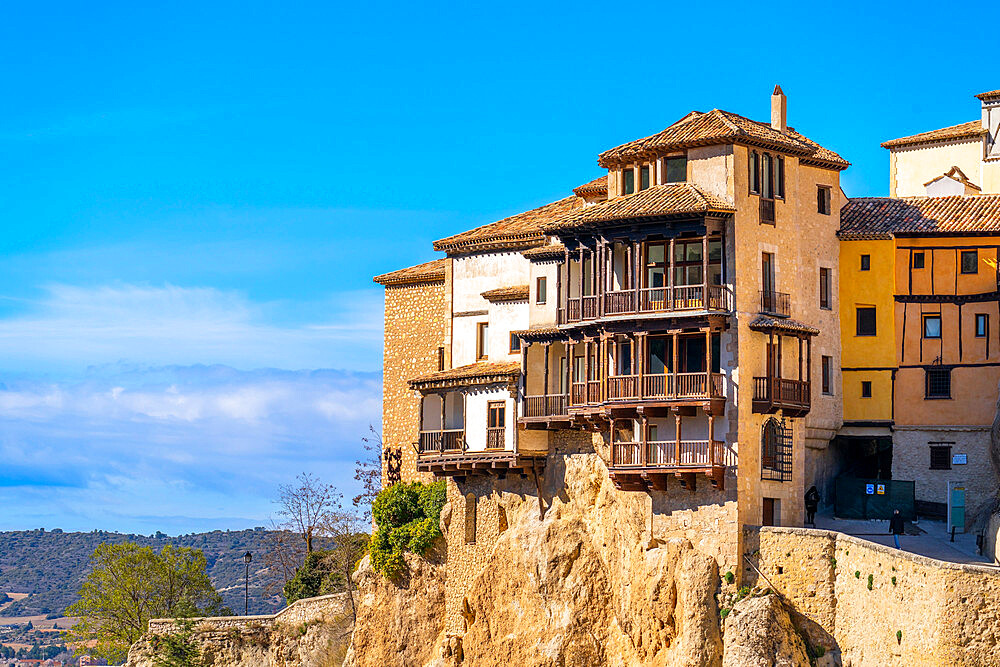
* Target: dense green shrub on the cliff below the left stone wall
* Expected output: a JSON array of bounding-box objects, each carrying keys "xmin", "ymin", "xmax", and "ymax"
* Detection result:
[{"xmin": 371, "ymin": 480, "xmax": 447, "ymax": 579}]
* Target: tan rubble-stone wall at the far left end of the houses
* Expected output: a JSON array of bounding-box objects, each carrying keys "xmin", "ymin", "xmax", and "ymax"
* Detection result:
[{"xmin": 382, "ymin": 272, "xmax": 450, "ymax": 484}]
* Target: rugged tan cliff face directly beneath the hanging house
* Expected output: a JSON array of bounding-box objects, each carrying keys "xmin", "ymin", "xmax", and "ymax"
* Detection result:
[{"xmin": 346, "ymin": 452, "xmax": 722, "ymax": 667}]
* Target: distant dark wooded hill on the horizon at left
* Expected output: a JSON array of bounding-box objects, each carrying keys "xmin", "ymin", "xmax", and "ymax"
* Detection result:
[{"xmin": 0, "ymin": 528, "xmax": 298, "ymax": 624}]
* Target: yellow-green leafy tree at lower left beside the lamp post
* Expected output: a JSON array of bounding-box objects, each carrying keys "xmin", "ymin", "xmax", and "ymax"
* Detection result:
[{"xmin": 66, "ymin": 542, "xmax": 231, "ymax": 662}]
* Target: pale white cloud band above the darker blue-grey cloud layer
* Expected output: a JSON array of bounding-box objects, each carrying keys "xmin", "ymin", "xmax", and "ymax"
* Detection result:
[{"xmin": 0, "ymin": 285, "xmax": 382, "ymax": 374}]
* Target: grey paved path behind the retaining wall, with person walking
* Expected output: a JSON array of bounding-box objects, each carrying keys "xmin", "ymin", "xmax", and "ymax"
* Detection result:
[{"xmin": 807, "ymin": 514, "xmax": 1000, "ymax": 569}]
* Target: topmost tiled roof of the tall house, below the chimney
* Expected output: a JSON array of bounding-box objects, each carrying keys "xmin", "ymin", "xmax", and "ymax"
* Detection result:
[{"xmin": 597, "ymin": 109, "xmax": 850, "ymax": 169}]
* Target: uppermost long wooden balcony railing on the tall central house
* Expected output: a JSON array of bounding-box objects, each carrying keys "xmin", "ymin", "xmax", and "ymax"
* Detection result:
[{"xmin": 559, "ymin": 285, "xmax": 732, "ymax": 324}]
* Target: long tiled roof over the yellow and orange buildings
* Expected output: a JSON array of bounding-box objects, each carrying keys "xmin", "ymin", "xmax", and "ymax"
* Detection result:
[{"xmin": 837, "ymin": 194, "xmax": 1000, "ymax": 239}]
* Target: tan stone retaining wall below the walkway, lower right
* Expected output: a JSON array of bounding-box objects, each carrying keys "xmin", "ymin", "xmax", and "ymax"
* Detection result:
[{"xmin": 745, "ymin": 528, "xmax": 1000, "ymax": 665}]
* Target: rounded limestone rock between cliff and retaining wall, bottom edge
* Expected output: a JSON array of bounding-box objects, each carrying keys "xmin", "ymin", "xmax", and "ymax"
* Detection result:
[{"xmin": 722, "ymin": 595, "xmax": 809, "ymax": 667}]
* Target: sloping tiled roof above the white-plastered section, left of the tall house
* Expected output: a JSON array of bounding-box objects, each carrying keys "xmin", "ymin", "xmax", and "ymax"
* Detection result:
[{"xmin": 434, "ymin": 196, "xmax": 583, "ymax": 254}]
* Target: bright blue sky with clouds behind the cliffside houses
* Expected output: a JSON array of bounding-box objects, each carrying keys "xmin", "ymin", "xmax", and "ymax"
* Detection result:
[{"xmin": 0, "ymin": 2, "xmax": 1000, "ymax": 533}]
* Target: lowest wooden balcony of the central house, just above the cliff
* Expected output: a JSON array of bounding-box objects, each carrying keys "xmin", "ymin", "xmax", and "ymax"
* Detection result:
[{"xmin": 609, "ymin": 440, "xmax": 725, "ymax": 490}]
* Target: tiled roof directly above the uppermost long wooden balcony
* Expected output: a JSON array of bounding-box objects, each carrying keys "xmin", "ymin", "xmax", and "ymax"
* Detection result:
[{"xmin": 546, "ymin": 183, "xmax": 736, "ymax": 232}]
